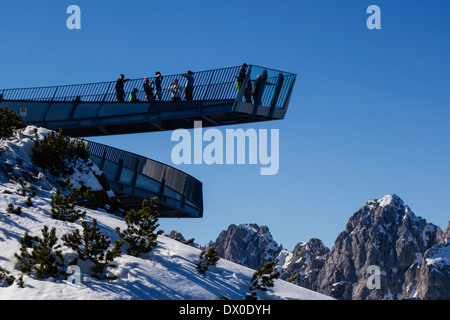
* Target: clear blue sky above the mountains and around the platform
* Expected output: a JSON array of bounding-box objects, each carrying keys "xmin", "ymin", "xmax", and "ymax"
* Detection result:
[{"xmin": 0, "ymin": 0, "xmax": 450, "ymax": 249}]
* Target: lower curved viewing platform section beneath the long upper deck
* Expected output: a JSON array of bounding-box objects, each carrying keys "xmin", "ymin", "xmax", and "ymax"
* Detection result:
[{"xmin": 86, "ymin": 141, "xmax": 203, "ymax": 218}]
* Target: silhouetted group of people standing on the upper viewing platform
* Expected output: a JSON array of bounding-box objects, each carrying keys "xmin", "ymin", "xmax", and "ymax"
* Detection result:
[{"xmin": 116, "ymin": 63, "xmax": 270, "ymax": 103}]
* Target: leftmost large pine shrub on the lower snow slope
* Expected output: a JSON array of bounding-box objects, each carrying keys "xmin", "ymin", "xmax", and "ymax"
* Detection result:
[{"xmin": 14, "ymin": 226, "xmax": 64, "ymax": 278}]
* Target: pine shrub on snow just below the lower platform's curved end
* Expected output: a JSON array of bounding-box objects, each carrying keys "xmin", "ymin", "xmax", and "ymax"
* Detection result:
[{"xmin": 116, "ymin": 198, "xmax": 162, "ymax": 256}]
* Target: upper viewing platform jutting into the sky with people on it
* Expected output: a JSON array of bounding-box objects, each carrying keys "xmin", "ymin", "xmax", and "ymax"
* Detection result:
[{"xmin": 0, "ymin": 65, "xmax": 296, "ymax": 137}]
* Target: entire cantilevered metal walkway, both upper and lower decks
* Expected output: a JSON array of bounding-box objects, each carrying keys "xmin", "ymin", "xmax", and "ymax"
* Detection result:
[{"xmin": 0, "ymin": 65, "xmax": 296, "ymax": 217}]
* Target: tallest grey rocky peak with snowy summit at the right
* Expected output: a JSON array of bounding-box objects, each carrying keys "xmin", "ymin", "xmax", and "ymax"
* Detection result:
[{"xmin": 317, "ymin": 195, "xmax": 442, "ymax": 299}]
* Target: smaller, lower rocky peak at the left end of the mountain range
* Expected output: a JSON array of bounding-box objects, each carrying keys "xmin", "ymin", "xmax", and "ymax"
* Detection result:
[{"xmin": 208, "ymin": 224, "xmax": 282, "ymax": 270}]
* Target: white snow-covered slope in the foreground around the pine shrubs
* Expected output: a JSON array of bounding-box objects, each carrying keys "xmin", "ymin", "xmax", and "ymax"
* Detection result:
[{"xmin": 0, "ymin": 128, "xmax": 331, "ymax": 300}]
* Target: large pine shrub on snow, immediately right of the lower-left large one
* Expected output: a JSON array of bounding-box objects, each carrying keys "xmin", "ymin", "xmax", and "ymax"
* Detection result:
[{"xmin": 62, "ymin": 219, "xmax": 123, "ymax": 278}]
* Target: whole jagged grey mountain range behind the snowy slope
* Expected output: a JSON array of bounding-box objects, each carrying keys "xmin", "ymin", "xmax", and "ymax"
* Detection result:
[{"xmin": 203, "ymin": 194, "xmax": 450, "ymax": 300}]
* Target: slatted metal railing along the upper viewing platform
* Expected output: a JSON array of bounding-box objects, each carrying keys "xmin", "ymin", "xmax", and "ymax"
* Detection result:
[{"xmin": 0, "ymin": 65, "xmax": 296, "ymax": 108}]
